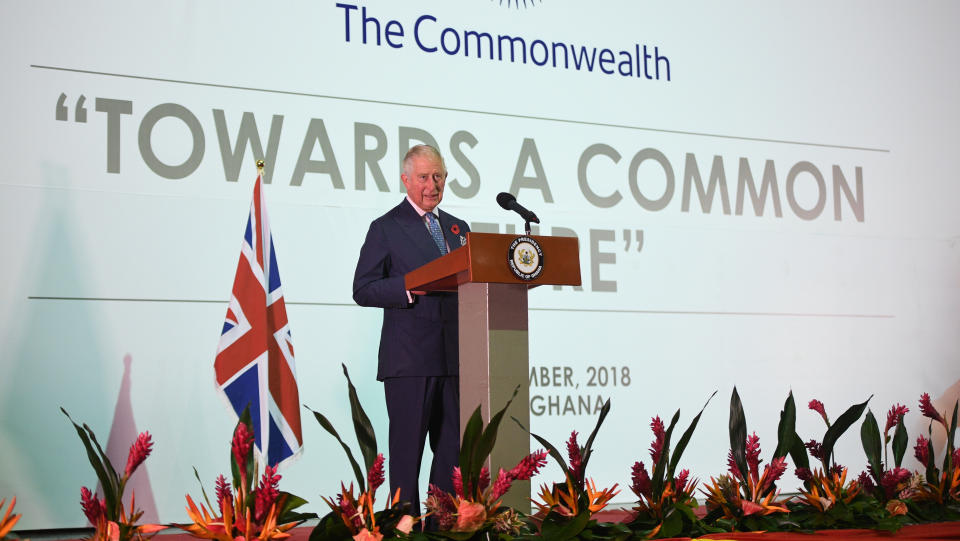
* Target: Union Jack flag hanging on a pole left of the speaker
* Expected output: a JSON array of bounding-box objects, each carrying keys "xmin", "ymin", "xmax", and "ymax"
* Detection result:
[{"xmin": 213, "ymin": 175, "xmax": 303, "ymax": 466}]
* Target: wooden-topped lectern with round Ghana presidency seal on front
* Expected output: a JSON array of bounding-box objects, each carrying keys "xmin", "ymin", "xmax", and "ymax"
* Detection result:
[{"xmin": 406, "ymin": 233, "xmax": 580, "ymax": 513}]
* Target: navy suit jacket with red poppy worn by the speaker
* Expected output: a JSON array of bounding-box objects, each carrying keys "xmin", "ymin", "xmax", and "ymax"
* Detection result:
[{"xmin": 353, "ymin": 198, "xmax": 470, "ymax": 381}]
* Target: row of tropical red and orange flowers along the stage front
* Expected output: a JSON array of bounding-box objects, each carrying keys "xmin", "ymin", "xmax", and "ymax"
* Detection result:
[{"xmin": 45, "ymin": 384, "xmax": 960, "ymax": 541}]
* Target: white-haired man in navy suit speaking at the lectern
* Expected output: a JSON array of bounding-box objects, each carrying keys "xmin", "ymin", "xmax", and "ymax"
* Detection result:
[{"xmin": 353, "ymin": 145, "xmax": 470, "ymax": 514}]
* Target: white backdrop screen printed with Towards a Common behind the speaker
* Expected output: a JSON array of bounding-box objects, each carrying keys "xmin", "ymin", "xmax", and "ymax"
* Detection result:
[{"xmin": 0, "ymin": 0, "xmax": 960, "ymax": 529}]
